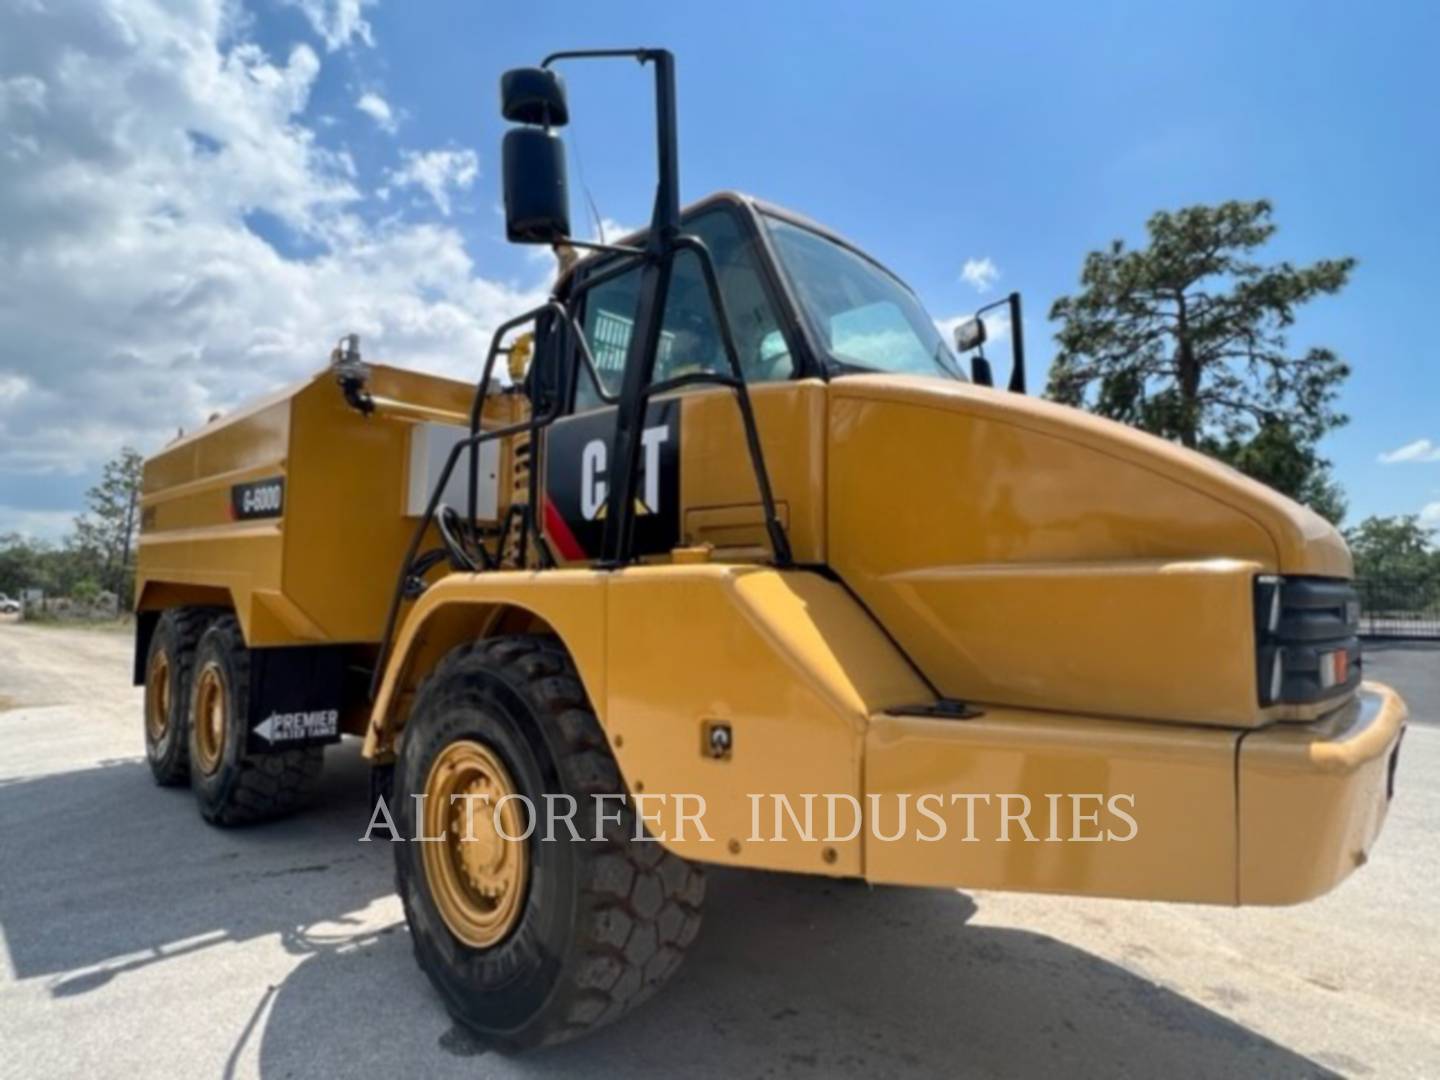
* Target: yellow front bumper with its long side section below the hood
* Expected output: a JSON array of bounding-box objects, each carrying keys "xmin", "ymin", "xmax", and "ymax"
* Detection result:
[{"xmin": 864, "ymin": 683, "xmax": 1405, "ymax": 904}]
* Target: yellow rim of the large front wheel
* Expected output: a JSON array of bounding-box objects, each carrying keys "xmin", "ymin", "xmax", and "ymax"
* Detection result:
[{"xmin": 422, "ymin": 740, "xmax": 530, "ymax": 949}]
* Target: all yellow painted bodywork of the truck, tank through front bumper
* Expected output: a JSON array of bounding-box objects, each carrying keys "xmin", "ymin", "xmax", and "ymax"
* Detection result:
[{"xmin": 137, "ymin": 360, "xmax": 1404, "ymax": 903}]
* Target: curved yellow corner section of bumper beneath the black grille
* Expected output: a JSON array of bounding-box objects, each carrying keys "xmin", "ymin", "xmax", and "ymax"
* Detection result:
[{"xmin": 1237, "ymin": 683, "xmax": 1408, "ymax": 904}]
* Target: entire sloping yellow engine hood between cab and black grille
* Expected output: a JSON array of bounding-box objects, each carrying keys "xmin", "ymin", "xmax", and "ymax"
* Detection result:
[{"xmin": 825, "ymin": 376, "xmax": 1351, "ymax": 727}]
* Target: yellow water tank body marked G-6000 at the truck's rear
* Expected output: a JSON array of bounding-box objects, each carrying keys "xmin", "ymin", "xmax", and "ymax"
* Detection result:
[{"xmin": 135, "ymin": 366, "xmax": 513, "ymax": 647}]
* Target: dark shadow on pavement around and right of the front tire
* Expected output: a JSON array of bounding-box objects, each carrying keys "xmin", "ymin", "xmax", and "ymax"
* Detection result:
[{"xmin": 255, "ymin": 871, "xmax": 1336, "ymax": 1077}]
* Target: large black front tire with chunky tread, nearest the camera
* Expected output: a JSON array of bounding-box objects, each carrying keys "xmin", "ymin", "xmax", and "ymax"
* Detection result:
[{"xmin": 390, "ymin": 635, "xmax": 704, "ymax": 1051}]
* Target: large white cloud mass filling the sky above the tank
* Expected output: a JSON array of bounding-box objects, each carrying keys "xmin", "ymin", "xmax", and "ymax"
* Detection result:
[{"xmin": 0, "ymin": 0, "xmax": 544, "ymax": 506}]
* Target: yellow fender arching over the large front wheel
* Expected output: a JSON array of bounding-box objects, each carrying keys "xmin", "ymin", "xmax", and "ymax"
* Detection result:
[{"xmin": 364, "ymin": 563, "xmax": 935, "ymax": 876}]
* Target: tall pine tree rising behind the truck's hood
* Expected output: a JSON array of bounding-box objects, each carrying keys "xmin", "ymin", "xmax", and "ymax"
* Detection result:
[{"xmin": 1047, "ymin": 199, "xmax": 1355, "ymax": 521}]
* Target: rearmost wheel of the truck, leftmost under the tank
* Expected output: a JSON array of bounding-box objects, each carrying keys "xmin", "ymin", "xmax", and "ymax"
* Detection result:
[{"xmin": 144, "ymin": 608, "xmax": 212, "ymax": 788}]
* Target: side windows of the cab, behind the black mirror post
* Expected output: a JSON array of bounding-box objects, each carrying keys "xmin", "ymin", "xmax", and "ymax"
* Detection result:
[{"xmin": 575, "ymin": 209, "xmax": 795, "ymax": 412}]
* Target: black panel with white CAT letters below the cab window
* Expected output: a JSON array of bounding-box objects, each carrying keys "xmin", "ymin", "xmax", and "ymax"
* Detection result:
[{"xmin": 543, "ymin": 400, "xmax": 680, "ymax": 562}]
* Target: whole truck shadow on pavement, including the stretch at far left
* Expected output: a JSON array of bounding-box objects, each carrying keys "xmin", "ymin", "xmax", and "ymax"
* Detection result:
[{"xmin": 0, "ymin": 747, "xmax": 1332, "ymax": 1077}]
